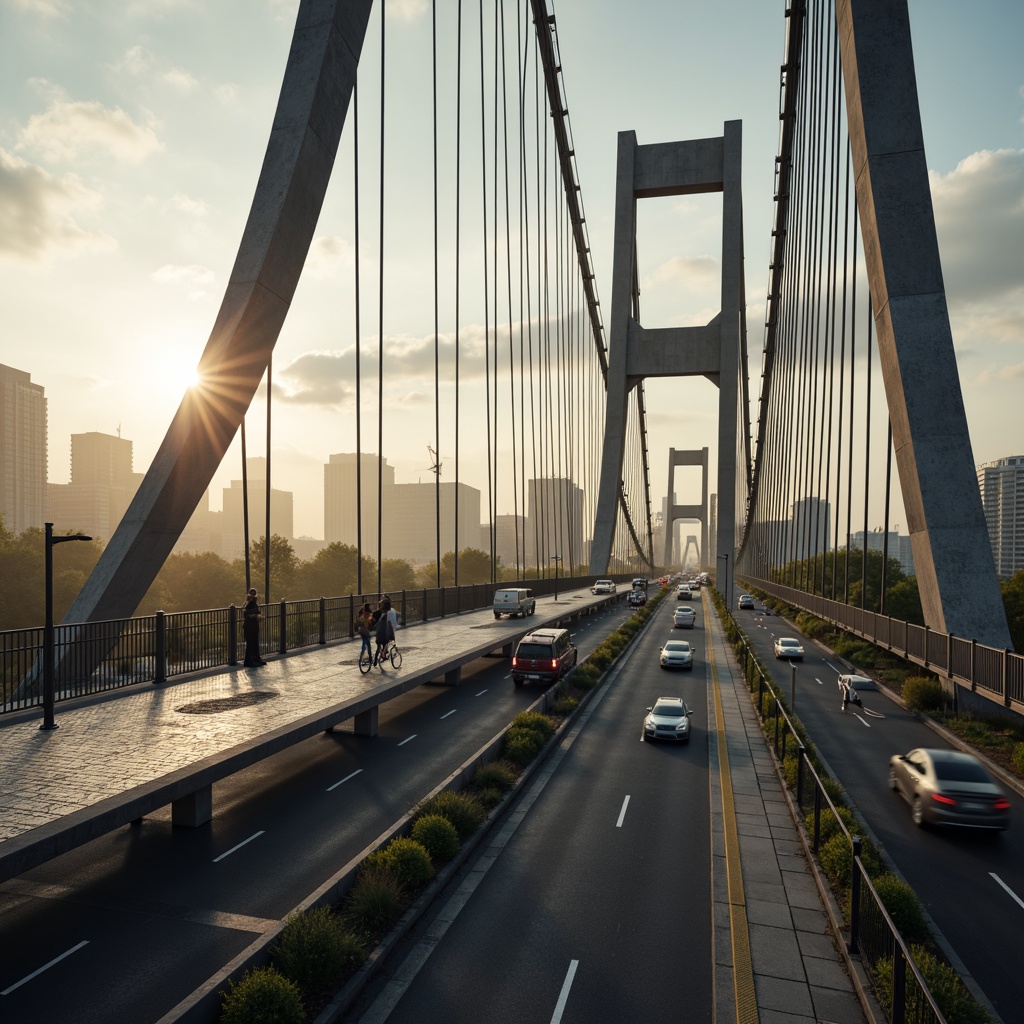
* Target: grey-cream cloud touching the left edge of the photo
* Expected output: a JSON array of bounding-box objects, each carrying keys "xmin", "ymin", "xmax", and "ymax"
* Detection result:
[{"xmin": 0, "ymin": 150, "xmax": 116, "ymax": 263}]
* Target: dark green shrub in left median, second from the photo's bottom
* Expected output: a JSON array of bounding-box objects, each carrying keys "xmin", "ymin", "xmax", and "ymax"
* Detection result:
[{"xmin": 270, "ymin": 906, "xmax": 367, "ymax": 996}]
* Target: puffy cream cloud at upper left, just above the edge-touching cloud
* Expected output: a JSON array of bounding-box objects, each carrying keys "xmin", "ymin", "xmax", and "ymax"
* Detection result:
[{"xmin": 16, "ymin": 99, "xmax": 164, "ymax": 164}]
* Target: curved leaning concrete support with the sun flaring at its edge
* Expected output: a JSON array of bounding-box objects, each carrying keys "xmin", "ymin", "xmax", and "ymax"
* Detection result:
[{"xmin": 58, "ymin": 0, "xmax": 372, "ymax": 647}]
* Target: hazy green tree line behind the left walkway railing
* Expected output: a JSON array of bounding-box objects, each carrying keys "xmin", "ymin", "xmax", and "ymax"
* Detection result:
[{"xmin": 0, "ymin": 518, "xmax": 515, "ymax": 630}]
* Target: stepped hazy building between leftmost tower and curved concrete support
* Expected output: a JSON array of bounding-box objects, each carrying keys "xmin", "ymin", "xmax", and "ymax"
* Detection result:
[{"xmin": 46, "ymin": 431, "xmax": 142, "ymax": 544}]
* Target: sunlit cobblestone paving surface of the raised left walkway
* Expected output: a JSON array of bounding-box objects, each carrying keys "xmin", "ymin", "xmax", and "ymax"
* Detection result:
[{"xmin": 0, "ymin": 591, "xmax": 591, "ymax": 849}]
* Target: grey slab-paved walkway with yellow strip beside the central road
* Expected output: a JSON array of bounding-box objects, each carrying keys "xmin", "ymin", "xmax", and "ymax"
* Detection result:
[{"xmin": 705, "ymin": 595, "xmax": 885, "ymax": 1024}]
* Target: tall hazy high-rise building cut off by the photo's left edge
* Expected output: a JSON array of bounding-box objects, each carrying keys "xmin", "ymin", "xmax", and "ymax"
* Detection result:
[{"xmin": 0, "ymin": 364, "xmax": 47, "ymax": 534}]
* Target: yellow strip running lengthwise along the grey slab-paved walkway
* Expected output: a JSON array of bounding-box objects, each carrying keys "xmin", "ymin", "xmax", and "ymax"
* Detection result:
[{"xmin": 700, "ymin": 594, "xmax": 759, "ymax": 1024}]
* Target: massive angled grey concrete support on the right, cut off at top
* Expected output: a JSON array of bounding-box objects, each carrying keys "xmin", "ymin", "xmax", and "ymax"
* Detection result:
[{"xmin": 836, "ymin": 0, "xmax": 1010, "ymax": 647}]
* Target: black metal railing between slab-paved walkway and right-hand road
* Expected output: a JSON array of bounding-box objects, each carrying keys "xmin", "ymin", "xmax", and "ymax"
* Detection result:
[{"xmin": 719, "ymin": 605, "xmax": 946, "ymax": 1024}]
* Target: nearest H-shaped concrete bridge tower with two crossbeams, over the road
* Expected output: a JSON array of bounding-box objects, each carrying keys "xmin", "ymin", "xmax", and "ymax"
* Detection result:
[{"xmin": 590, "ymin": 128, "xmax": 750, "ymax": 606}]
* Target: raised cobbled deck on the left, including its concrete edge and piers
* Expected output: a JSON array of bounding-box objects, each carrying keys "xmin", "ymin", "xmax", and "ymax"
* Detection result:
[{"xmin": 0, "ymin": 591, "xmax": 624, "ymax": 881}]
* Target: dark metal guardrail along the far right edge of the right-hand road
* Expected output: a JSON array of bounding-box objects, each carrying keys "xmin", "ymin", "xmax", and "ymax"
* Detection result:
[{"xmin": 743, "ymin": 577, "xmax": 1024, "ymax": 712}]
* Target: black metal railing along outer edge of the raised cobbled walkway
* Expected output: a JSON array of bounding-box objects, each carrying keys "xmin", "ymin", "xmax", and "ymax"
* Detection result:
[{"xmin": 0, "ymin": 574, "xmax": 632, "ymax": 715}]
